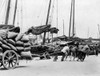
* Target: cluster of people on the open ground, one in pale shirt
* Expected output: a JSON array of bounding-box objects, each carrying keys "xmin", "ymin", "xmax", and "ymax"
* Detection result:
[{"xmin": 54, "ymin": 42, "xmax": 99, "ymax": 61}]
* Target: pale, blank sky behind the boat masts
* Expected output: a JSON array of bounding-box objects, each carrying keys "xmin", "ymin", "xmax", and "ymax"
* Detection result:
[{"xmin": 0, "ymin": 0, "xmax": 100, "ymax": 38}]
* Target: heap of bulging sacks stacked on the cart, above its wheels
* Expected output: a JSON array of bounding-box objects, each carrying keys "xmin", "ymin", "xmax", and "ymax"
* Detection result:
[{"xmin": 0, "ymin": 30, "xmax": 31, "ymax": 54}]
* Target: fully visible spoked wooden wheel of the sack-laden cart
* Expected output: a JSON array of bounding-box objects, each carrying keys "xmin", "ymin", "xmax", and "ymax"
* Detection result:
[{"xmin": 2, "ymin": 50, "xmax": 18, "ymax": 69}]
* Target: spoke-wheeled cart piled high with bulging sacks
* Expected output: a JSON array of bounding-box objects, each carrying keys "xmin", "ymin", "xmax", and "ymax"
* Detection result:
[{"xmin": 0, "ymin": 27, "xmax": 32, "ymax": 69}]
